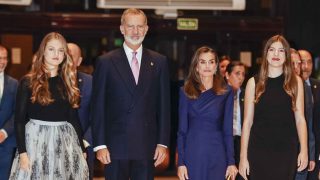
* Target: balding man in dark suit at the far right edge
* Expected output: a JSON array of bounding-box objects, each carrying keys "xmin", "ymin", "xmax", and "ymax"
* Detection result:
[{"xmin": 296, "ymin": 50, "xmax": 320, "ymax": 180}]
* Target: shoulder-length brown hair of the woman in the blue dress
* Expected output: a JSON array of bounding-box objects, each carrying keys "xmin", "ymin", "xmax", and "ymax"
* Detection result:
[{"xmin": 184, "ymin": 46, "xmax": 227, "ymax": 99}]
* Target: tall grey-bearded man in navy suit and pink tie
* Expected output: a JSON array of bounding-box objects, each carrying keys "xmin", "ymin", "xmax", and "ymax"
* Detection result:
[{"xmin": 92, "ymin": 9, "xmax": 170, "ymax": 180}]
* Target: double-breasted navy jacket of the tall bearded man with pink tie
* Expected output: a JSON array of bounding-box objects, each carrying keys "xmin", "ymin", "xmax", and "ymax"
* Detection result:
[{"xmin": 92, "ymin": 48, "xmax": 170, "ymax": 160}]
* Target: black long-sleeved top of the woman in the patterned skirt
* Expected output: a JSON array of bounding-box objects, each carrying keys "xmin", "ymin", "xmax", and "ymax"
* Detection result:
[{"xmin": 15, "ymin": 76, "xmax": 85, "ymax": 153}]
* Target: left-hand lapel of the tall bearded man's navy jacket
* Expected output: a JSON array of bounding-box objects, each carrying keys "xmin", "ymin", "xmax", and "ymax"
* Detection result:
[{"xmin": 112, "ymin": 48, "xmax": 136, "ymax": 94}]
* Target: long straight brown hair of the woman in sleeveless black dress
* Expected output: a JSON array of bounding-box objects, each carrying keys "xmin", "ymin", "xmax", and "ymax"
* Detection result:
[{"xmin": 255, "ymin": 35, "xmax": 298, "ymax": 110}]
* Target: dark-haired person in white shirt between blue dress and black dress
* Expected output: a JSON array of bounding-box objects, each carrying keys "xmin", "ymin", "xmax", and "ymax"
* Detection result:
[{"xmin": 225, "ymin": 61, "xmax": 246, "ymax": 180}]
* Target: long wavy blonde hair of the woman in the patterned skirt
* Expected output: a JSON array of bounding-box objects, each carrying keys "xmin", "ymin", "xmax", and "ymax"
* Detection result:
[{"xmin": 26, "ymin": 32, "xmax": 80, "ymax": 108}]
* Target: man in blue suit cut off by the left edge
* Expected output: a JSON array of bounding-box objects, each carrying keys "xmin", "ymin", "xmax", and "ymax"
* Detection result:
[{"xmin": 0, "ymin": 45, "xmax": 18, "ymax": 180}]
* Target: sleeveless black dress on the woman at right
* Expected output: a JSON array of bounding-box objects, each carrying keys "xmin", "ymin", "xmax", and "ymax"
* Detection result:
[{"xmin": 248, "ymin": 74, "xmax": 298, "ymax": 180}]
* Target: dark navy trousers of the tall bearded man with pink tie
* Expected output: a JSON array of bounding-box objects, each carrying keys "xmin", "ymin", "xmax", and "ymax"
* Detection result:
[{"xmin": 105, "ymin": 159, "xmax": 154, "ymax": 180}]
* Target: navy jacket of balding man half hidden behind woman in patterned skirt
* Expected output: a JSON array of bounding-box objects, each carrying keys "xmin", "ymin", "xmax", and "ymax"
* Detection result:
[{"xmin": 78, "ymin": 72, "xmax": 92, "ymax": 144}]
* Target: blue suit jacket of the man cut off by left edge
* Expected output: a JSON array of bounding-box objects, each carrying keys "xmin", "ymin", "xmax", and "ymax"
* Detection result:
[{"xmin": 0, "ymin": 74, "xmax": 18, "ymax": 148}]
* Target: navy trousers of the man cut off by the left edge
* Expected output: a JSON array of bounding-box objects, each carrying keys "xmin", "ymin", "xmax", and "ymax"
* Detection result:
[{"xmin": 0, "ymin": 147, "xmax": 15, "ymax": 180}]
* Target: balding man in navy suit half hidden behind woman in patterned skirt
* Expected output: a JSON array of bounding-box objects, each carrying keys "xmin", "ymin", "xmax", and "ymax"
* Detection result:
[{"xmin": 68, "ymin": 43, "xmax": 94, "ymax": 179}]
